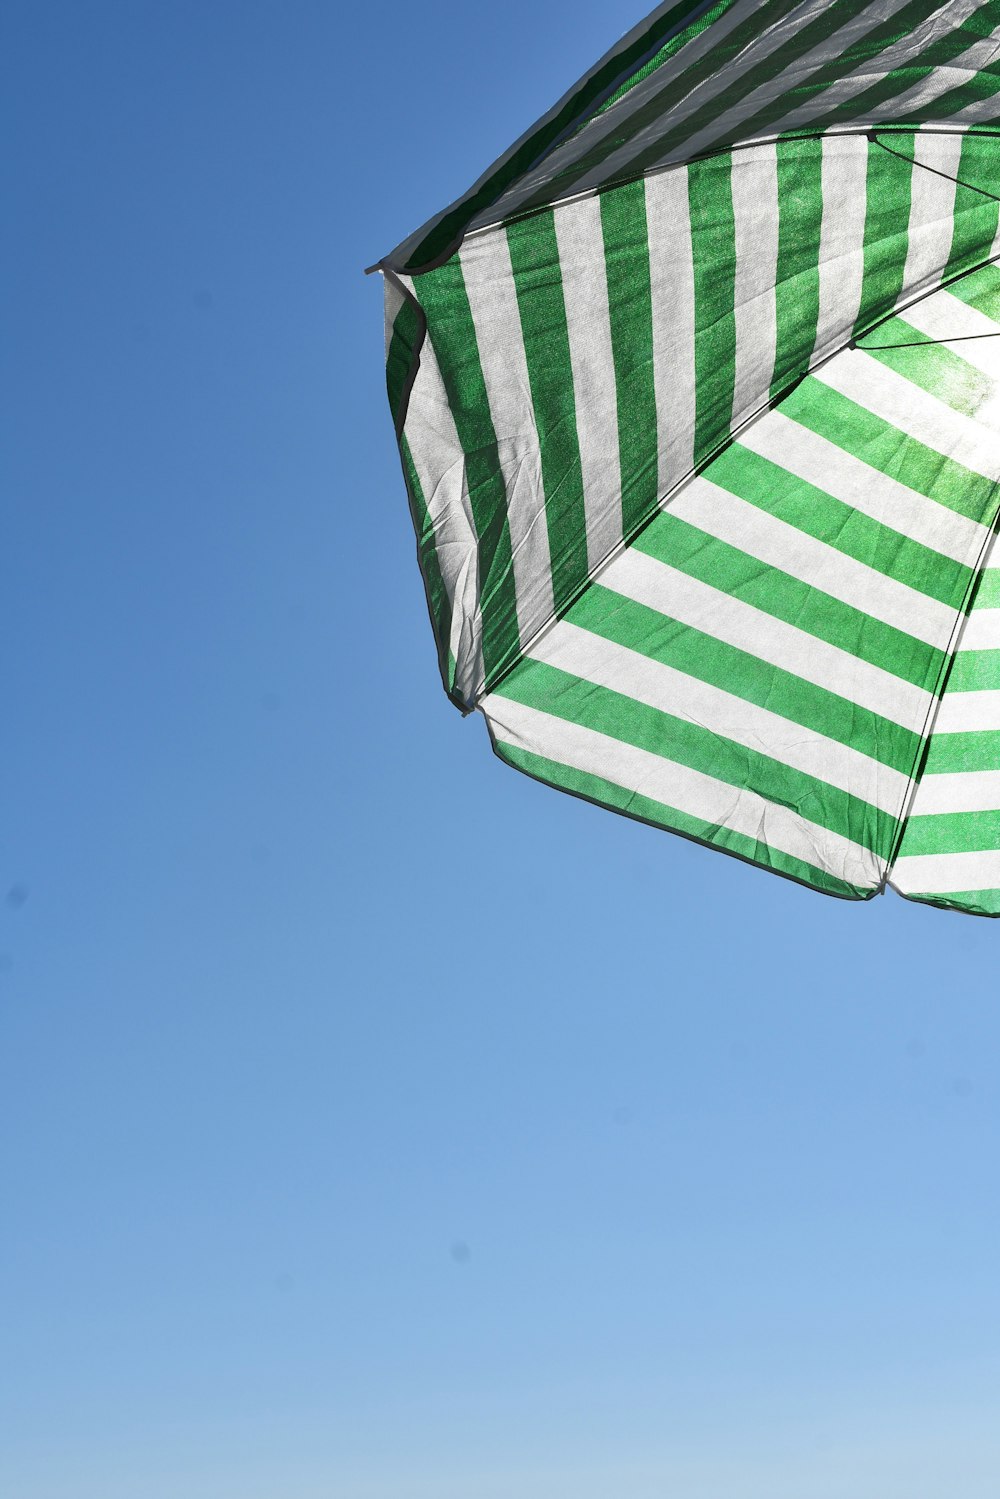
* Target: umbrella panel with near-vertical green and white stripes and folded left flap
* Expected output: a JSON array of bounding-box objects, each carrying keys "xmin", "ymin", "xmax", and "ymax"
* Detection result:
[{"xmin": 387, "ymin": 132, "xmax": 997, "ymax": 709}]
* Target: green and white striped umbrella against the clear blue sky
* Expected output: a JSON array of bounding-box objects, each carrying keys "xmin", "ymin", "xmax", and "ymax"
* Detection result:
[{"xmin": 379, "ymin": 0, "xmax": 1000, "ymax": 914}]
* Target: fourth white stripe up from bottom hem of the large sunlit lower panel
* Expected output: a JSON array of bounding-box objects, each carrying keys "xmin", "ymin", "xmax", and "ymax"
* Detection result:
[{"xmin": 666, "ymin": 477, "xmax": 955, "ymax": 651}]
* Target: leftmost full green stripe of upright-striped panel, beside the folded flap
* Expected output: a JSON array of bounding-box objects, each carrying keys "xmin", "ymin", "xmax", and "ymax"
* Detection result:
[{"xmin": 417, "ymin": 259, "xmax": 520, "ymax": 687}]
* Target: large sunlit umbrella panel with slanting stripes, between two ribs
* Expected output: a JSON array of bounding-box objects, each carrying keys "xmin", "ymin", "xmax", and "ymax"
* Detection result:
[{"xmin": 481, "ymin": 292, "xmax": 997, "ymax": 898}]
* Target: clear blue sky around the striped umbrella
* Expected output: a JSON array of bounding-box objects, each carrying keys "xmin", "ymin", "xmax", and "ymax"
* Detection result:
[{"xmin": 0, "ymin": 0, "xmax": 1000, "ymax": 1499}]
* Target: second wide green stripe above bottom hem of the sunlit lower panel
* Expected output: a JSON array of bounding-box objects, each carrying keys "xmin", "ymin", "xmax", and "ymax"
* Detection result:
[{"xmin": 567, "ymin": 583, "xmax": 922, "ymax": 775}]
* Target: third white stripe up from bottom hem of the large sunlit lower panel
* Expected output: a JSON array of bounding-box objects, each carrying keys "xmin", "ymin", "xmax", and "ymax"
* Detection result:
[{"xmin": 601, "ymin": 549, "xmax": 931, "ymax": 732}]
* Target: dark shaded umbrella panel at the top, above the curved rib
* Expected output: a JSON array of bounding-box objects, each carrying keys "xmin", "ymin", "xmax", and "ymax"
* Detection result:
[{"xmin": 384, "ymin": 0, "xmax": 1000, "ymax": 271}]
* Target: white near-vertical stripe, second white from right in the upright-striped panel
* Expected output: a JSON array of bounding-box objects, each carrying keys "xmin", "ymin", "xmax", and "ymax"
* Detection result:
[{"xmin": 813, "ymin": 135, "xmax": 868, "ymax": 360}]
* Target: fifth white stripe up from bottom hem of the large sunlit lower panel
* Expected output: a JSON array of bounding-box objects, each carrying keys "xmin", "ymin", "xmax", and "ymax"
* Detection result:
[{"xmin": 738, "ymin": 411, "xmax": 987, "ymax": 565}]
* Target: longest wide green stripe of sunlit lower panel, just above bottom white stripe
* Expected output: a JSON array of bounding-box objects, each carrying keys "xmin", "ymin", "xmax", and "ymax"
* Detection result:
[{"xmin": 499, "ymin": 661, "xmax": 897, "ymax": 857}]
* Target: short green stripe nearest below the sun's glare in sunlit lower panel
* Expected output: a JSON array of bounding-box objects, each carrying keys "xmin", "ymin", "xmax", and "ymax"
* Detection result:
[{"xmin": 781, "ymin": 375, "xmax": 999, "ymax": 525}]
